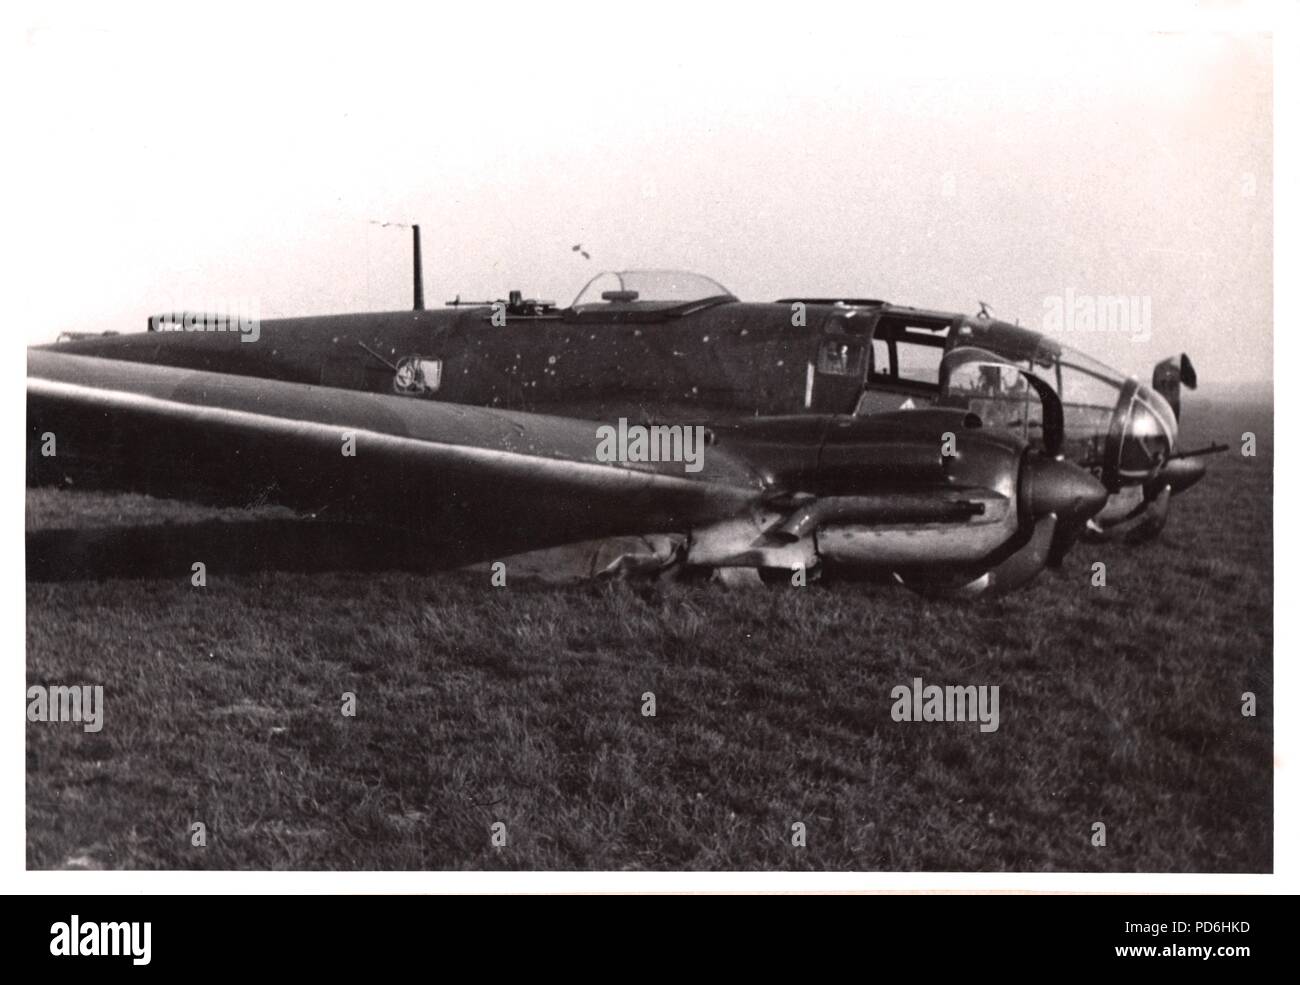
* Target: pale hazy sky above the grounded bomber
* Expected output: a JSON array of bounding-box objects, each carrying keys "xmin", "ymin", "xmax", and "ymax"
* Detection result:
[{"xmin": 10, "ymin": 4, "xmax": 1273, "ymax": 382}]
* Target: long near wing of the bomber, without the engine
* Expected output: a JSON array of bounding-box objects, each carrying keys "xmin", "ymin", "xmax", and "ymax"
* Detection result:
[{"xmin": 27, "ymin": 350, "xmax": 763, "ymax": 551}]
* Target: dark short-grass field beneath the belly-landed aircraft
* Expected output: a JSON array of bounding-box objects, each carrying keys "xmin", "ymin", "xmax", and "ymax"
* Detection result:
[{"xmin": 26, "ymin": 404, "xmax": 1273, "ymax": 872}]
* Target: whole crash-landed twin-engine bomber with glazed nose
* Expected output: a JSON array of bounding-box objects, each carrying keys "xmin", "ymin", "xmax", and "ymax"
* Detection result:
[{"xmin": 27, "ymin": 230, "xmax": 1218, "ymax": 596}]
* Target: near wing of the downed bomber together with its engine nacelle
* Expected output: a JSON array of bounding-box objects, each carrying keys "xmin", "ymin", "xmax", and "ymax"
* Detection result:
[{"xmin": 27, "ymin": 350, "xmax": 1105, "ymax": 593}]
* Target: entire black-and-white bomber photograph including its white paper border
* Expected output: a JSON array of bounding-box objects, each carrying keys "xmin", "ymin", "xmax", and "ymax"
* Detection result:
[{"xmin": 5, "ymin": 3, "xmax": 1295, "ymax": 894}]
